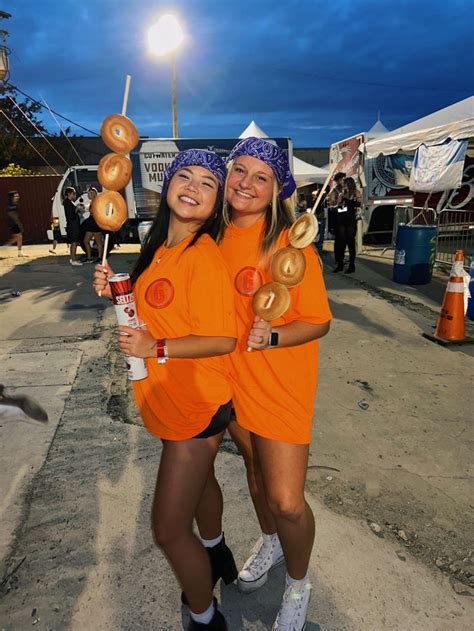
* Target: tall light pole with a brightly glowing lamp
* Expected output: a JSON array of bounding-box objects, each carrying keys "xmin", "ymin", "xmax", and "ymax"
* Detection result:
[{"xmin": 148, "ymin": 14, "xmax": 184, "ymax": 138}]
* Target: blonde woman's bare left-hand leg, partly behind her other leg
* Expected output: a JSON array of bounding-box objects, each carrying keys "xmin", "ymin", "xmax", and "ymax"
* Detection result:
[{"xmin": 228, "ymin": 422, "xmax": 277, "ymax": 535}]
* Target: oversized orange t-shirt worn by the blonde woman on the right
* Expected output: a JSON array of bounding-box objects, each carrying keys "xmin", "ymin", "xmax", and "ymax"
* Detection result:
[{"xmin": 220, "ymin": 220, "xmax": 331, "ymax": 444}]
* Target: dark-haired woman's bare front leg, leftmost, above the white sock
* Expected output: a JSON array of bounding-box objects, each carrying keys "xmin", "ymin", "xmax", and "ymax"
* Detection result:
[{"xmin": 152, "ymin": 434, "xmax": 222, "ymax": 613}]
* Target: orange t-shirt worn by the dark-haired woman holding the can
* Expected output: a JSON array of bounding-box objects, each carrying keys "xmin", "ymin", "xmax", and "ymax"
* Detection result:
[{"xmin": 133, "ymin": 235, "xmax": 236, "ymax": 440}]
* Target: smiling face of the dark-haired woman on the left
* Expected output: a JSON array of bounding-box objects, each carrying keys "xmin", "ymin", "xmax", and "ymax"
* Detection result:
[{"xmin": 166, "ymin": 166, "xmax": 219, "ymax": 226}]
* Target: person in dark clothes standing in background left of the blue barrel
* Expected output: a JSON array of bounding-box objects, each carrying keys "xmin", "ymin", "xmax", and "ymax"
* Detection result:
[{"xmin": 334, "ymin": 177, "xmax": 362, "ymax": 274}]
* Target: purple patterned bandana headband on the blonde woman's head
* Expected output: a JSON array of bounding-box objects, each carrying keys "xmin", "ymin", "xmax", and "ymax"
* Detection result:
[{"xmin": 227, "ymin": 137, "xmax": 296, "ymax": 200}]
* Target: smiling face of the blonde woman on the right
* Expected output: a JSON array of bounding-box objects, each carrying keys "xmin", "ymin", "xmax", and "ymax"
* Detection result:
[{"xmin": 227, "ymin": 156, "xmax": 275, "ymax": 221}]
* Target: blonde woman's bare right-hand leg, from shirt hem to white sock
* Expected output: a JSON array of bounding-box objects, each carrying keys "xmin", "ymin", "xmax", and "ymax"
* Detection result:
[{"xmin": 252, "ymin": 434, "xmax": 314, "ymax": 580}]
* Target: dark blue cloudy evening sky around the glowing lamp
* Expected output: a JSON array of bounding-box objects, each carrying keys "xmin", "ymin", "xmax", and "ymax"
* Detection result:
[{"xmin": 0, "ymin": 0, "xmax": 474, "ymax": 147}]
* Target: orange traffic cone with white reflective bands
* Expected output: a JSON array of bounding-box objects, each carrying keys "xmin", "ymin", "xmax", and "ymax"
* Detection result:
[{"xmin": 424, "ymin": 250, "xmax": 465, "ymax": 343}]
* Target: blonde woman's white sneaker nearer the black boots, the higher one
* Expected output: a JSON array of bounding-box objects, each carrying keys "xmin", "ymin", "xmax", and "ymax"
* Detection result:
[{"xmin": 237, "ymin": 534, "xmax": 285, "ymax": 593}]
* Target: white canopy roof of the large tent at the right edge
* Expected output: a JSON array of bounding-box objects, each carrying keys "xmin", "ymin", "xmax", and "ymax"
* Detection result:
[{"xmin": 365, "ymin": 96, "xmax": 474, "ymax": 158}]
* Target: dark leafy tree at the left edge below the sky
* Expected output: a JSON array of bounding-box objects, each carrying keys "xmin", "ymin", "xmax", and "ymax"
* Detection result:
[{"xmin": 0, "ymin": 84, "xmax": 47, "ymax": 169}]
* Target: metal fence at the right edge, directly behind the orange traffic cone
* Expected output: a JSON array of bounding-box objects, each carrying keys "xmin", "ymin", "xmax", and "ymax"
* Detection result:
[{"xmin": 435, "ymin": 208, "xmax": 474, "ymax": 269}]
